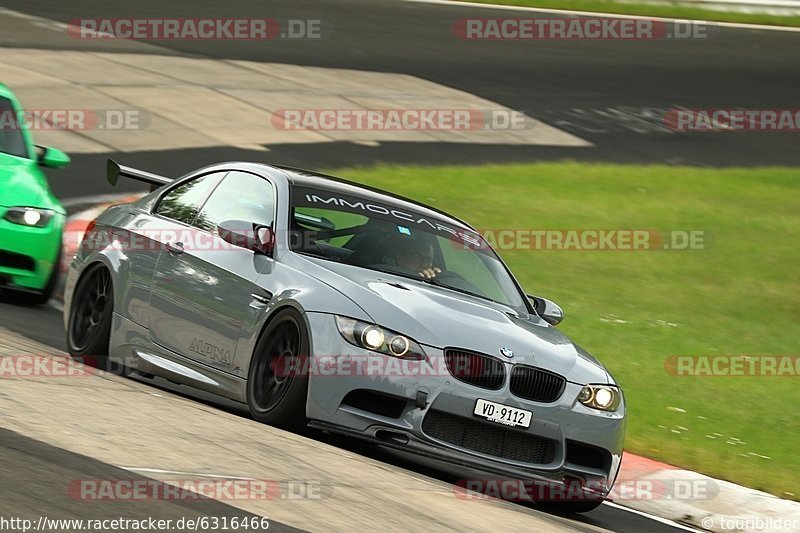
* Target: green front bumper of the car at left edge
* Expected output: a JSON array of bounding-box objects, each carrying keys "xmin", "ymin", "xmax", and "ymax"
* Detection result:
[{"xmin": 0, "ymin": 213, "xmax": 65, "ymax": 291}]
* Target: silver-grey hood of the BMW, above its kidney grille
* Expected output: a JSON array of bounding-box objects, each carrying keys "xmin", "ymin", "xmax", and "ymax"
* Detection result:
[{"xmin": 296, "ymin": 256, "xmax": 609, "ymax": 384}]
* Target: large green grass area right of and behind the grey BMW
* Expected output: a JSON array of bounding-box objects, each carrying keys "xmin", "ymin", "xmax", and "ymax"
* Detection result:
[{"xmin": 328, "ymin": 162, "xmax": 800, "ymax": 500}]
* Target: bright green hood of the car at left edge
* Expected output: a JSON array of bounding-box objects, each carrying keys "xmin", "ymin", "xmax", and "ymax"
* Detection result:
[{"xmin": 0, "ymin": 153, "xmax": 63, "ymax": 213}]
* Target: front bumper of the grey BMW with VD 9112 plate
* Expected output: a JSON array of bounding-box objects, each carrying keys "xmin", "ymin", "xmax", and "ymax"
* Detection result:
[{"xmin": 300, "ymin": 313, "xmax": 625, "ymax": 496}]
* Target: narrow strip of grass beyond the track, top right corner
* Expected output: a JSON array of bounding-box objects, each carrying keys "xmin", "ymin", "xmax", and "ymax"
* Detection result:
[{"xmin": 454, "ymin": 0, "xmax": 800, "ymax": 28}]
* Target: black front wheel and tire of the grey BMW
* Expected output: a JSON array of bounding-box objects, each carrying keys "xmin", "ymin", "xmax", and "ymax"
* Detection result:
[{"xmin": 247, "ymin": 308, "xmax": 309, "ymax": 431}]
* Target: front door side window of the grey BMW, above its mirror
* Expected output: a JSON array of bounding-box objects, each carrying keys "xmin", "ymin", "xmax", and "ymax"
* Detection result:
[{"xmin": 195, "ymin": 171, "xmax": 275, "ymax": 231}]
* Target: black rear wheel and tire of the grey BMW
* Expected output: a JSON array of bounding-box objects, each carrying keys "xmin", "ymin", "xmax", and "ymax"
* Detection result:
[{"xmin": 67, "ymin": 264, "xmax": 114, "ymax": 370}]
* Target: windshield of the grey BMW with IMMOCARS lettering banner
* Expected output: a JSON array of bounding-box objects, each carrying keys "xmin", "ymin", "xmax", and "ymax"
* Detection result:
[{"xmin": 290, "ymin": 186, "xmax": 527, "ymax": 313}]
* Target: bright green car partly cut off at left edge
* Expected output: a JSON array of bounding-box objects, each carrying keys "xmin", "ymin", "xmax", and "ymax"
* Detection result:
[{"xmin": 0, "ymin": 84, "xmax": 70, "ymax": 304}]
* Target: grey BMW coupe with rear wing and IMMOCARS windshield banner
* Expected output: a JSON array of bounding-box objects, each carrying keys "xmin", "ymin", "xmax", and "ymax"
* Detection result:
[{"xmin": 64, "ymin": 161, "xmax": 626, "ymax": 512}]
